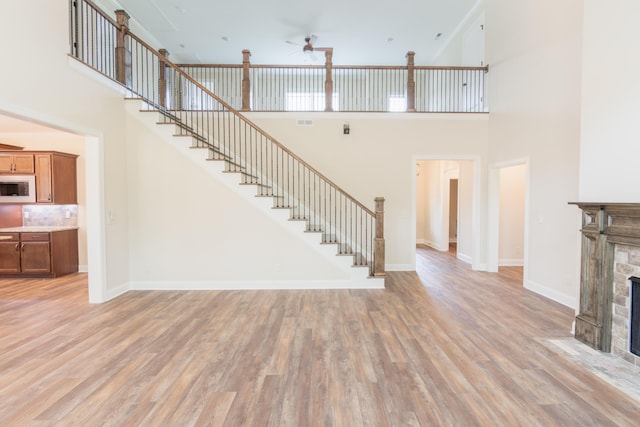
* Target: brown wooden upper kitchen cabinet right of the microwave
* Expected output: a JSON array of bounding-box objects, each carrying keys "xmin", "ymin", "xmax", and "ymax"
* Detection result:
[{"xmin": 34, "ymin": 151, "xmax": 78, "ymax": 205}]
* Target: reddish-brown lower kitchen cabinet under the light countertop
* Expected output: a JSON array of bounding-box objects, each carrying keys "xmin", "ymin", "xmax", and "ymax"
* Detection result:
[{"xmin": 0, "ymin": 229, "xmax": 78, "ymax": 277}]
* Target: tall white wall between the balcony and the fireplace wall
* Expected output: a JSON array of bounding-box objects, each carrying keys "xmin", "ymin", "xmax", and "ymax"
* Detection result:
[{"xmin": 485, "ymin": 0, "xmax": 584, "ymax": 307}]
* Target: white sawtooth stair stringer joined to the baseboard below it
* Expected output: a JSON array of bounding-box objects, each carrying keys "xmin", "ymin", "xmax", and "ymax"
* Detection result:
[{"xmin": 126, "ymin": 100, "xmax": 384, "ymax": 289}]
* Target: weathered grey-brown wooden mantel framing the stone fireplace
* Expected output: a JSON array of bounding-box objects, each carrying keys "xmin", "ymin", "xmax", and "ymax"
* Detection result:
[{"xmin": 570, "ymin": 202, "xmax": 640, "ymax": 352}]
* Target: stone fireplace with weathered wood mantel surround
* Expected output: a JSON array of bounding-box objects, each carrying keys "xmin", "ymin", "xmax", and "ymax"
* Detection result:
[{"xmin": 573, "ymin": 203, "xmax": 640, "ymax": 366}]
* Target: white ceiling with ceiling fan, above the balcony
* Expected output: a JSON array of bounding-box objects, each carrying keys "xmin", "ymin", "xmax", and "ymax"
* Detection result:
[{"xmin": 108, "ymin": 0, "xmax": 481, "ymax": 65}]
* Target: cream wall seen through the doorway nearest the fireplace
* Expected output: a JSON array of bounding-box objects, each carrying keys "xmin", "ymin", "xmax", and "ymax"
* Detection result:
[{"xmin": 499, "ymin": 165, "xmax": 526, "ymax": 266}]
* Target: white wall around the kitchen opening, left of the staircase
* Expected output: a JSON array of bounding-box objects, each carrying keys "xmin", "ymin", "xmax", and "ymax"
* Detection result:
[{"xmin": 0, "ymin": 0, "xmax": 129, "ymax": 301}]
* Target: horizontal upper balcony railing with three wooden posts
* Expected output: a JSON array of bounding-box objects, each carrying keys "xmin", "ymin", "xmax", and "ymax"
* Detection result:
[{"xmin": 180, "ymin": 49, "xmax": 488, "ymax": 113}]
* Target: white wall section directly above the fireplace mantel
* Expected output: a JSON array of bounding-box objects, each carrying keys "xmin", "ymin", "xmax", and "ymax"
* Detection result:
[{"xmin": 576, "ymin": 0, "xmax": 640, "ymax": 201}]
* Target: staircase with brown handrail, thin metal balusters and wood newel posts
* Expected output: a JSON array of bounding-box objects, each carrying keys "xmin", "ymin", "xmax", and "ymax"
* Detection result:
[{"xmin": 70, "ymin": 0, "xmax": 385, "ymax": 287}]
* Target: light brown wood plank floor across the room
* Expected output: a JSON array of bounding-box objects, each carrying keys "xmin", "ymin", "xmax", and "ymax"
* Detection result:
[{"xmin": 0, "ymin": 248, "xmax": 640, "ymax": 427}]
